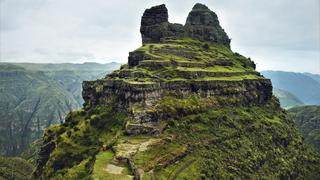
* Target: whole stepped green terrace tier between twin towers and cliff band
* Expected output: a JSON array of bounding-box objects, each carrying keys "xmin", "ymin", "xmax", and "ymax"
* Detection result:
[{"xmin": 106, "ymin": 39, "xmax": 261, "ymax": 84}]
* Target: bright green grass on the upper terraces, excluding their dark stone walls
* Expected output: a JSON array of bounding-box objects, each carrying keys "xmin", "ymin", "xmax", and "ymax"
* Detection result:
[{"xmin": 105, "ymin": 36, "xmax": 262, "ymax": 85}]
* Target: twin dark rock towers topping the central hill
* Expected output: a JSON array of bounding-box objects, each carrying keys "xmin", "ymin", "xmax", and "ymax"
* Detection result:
[{"xmin": 140, "ymin": 3, "xmax": 230, "ymax": 47}]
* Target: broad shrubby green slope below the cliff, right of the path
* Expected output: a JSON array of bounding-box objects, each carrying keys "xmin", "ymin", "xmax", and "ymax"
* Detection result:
[{"xmin": 156, "ymin": 98, "xmax": 319, "ymax": 179}]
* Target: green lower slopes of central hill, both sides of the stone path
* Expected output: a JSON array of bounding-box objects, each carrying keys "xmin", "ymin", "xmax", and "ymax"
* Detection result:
[{"xmin": 34, "ymin": 98, "xmax": 320, "ymax": 179}]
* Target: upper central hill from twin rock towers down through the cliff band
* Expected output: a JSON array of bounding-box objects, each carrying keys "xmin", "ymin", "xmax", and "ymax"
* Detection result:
[{"xmin": 83, "ymin": 4, "xmax": 272, "ymax": 135}]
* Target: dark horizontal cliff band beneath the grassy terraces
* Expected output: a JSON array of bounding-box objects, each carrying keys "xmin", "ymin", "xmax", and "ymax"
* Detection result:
[{"xmin": 83, "ymin": 79, "xmax": 272, "ymax": 111}]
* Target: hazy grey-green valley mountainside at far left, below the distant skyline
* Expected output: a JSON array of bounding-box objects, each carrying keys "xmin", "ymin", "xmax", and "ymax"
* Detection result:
[{"xmin": 0, "ymin": 65, "xmax": 79, "ymax": 155}]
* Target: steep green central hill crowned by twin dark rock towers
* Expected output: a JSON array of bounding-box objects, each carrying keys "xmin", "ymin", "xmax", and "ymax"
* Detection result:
[{"xmin": 33, "ymin": 4, "xmax": 320, "ymax": 179}]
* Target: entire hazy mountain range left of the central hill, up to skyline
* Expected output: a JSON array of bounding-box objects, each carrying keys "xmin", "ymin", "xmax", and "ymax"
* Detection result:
[{"xmin": 0, "ymin": 63, "xmax": 120, "ymax": 155}]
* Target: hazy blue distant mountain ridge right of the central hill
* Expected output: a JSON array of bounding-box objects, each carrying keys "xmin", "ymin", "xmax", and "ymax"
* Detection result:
[{"xmin": 261, "ymin": 71, "xmax": 320, "ymax": 105}]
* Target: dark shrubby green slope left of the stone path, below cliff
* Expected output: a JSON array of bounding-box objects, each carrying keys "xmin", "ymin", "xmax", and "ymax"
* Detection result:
[{"xmin": 32, "ymin": 107, "xmax": 126, "ymax": 179}]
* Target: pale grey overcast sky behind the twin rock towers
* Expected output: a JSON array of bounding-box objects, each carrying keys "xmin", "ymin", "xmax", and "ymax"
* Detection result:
[{"xmin": 0, "ymin": 0, "xmax": 320, "ymax": 73}]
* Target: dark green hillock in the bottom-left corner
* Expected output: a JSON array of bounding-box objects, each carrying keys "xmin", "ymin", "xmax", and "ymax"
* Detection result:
[{"xmin": 0, "ymin": 156, "xmax": 33, "ymax": 180}]
